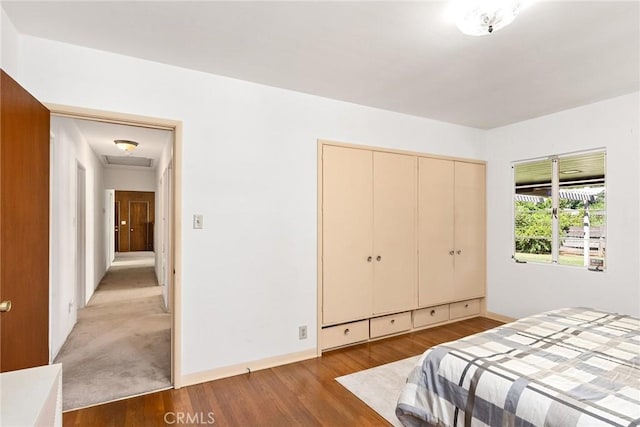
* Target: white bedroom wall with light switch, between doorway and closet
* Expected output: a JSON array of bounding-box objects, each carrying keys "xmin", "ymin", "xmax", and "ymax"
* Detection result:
[{"xmin": 18, "ymin": 36, "xmax": 486, "ymax": 380}]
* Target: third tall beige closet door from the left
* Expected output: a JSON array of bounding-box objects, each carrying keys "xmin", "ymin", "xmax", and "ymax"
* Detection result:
[{"xmin": 418, "ymin": 157, "xmax": 455, "ymax": 307}]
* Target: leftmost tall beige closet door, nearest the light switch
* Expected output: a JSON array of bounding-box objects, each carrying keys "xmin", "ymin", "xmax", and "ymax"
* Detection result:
[{"xmin": 322, "ymin": 145, "xmax": 373, "ymax": 325}]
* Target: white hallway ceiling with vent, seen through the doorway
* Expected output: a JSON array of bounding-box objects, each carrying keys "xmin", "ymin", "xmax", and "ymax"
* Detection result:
[{"xmin": 53, "ymin": 116, "xmax": 173, "ymax": 170}]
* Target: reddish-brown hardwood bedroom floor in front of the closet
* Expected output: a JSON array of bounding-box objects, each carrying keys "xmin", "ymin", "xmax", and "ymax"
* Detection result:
[{"xmin": 63, "ymin": 317, "xmax": 501, "ymax": 426}]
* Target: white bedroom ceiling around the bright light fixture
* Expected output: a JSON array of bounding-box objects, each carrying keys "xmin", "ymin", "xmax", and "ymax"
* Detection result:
[{"xmin": 2, "ymin": 0, "xmax": 640, "ymax": 129}]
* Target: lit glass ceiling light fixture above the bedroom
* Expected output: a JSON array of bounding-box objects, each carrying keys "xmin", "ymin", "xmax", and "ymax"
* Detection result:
[{"xmin": 447, "ymin": 0, "xmax": 532, "ymax": 36}]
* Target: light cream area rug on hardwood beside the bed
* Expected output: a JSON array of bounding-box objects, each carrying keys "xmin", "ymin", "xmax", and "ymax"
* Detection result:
[{"xmin": 336, "ymin": 355, "xmax": 420, "ymax": 427}]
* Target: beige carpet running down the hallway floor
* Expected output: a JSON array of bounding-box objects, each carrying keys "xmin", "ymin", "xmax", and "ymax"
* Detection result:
[{"xmin": 55, "ymin": 253, "xmax": 171, "ymax": 411}]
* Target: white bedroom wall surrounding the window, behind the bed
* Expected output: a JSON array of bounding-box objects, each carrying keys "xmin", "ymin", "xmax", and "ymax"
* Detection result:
[{"xmin": 487, "ymin": 93, "xmax": 640, "ymax": 317}]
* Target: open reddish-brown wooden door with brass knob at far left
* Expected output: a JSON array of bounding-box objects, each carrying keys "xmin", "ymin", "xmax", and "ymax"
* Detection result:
[{"xmin": 0, "ymin": 71, "xmax": 50, "ymax": 372}]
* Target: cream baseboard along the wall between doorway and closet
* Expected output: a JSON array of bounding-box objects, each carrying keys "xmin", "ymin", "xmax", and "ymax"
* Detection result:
[{"xmin": 180, "ymin": 348, "xmax": 318, "ymax": 387}]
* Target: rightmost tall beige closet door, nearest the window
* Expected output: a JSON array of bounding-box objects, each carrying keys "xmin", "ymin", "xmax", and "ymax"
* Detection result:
[{"xmin": 454, "ymin": 162, "xmax": 486, "ymax": 299}]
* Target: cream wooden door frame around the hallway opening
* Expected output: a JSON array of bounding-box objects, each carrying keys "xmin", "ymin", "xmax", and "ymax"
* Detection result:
[{"xmin": 44, "ymin": 103, "xmax": 183, "ymax": 388}]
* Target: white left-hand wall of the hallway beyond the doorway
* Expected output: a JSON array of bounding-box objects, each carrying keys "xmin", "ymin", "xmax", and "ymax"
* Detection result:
[{"xmin": 50, "ymin": 117, "xmax": 107, "ymax": 360}]
